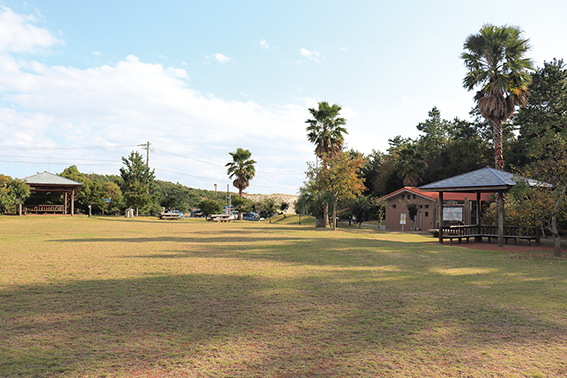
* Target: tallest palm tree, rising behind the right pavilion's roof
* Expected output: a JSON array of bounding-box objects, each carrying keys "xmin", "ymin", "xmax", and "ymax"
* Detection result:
[{"xmin": 461, "ymin": 24, "xmax": 533, "ymax": 169}]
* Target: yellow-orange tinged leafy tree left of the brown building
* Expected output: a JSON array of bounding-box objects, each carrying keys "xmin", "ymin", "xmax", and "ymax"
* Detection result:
[{"xmin": 308, "ymin": 152, "xmax": 365, "ymax": 230}]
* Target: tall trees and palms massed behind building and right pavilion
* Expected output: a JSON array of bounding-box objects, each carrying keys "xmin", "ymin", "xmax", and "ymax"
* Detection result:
[{"xmin": 296, "ymin": 25, "xmax": 567, "ymax": 250}]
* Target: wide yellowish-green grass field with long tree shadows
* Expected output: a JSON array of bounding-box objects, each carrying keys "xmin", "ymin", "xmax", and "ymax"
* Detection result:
[{"xmin": 0, "ymin": 216, "xmax": 567, "ymax": 377}]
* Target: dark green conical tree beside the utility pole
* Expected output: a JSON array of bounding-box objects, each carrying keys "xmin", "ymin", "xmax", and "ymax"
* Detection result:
[{"xmin": 120, "ymin": 151, "xmax": 155, "ymax": 216}]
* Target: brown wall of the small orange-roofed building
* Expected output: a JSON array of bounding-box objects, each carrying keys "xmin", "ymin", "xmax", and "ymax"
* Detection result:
[{"xmin": 385, "ymin": 191, "xmax": 435, "ymax": 231}]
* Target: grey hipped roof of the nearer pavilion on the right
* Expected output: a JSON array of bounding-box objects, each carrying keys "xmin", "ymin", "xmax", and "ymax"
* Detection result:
[{"xmin": 419, "ymin": 167, "xmax": 520, "ymax": 192}]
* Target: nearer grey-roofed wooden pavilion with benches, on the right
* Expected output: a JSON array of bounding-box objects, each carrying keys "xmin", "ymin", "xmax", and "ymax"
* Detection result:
[{"xmin": 419, "ymin": 167, "xmax": 541, "ymax": 248}]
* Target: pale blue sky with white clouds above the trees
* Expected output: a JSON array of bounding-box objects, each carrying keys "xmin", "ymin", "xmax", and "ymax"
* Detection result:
[{"xmin": 0, "ymin": 0, "xmax": 567, "ymax": 194}]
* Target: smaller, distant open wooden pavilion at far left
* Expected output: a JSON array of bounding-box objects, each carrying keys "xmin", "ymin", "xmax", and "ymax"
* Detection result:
[{"xmin": 24, "ymin": 172, "xmax": 83, "ymax": 215}]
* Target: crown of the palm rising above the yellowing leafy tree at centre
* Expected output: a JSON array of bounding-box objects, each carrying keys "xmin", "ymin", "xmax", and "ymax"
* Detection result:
[{"xmin": 305, "ymin": 101, "xmax": 348, "ymax": 158}]
